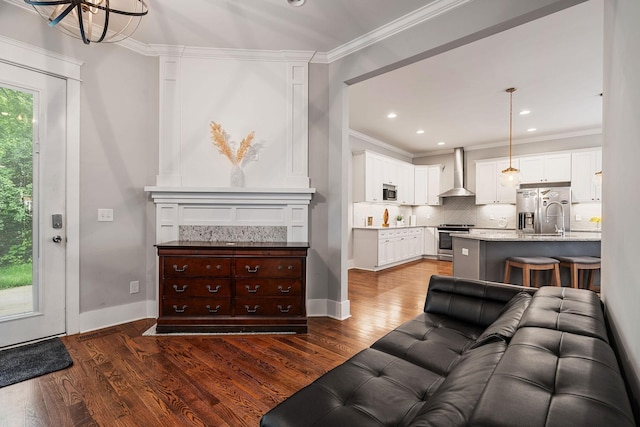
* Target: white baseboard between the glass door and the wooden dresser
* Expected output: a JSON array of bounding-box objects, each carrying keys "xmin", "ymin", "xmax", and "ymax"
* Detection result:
[{"xmin": 80, "ymin": 300, "xmax": 156, "ymax": 333}]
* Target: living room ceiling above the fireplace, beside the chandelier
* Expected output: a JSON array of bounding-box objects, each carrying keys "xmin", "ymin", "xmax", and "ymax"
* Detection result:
[{"xmin": 117, "ymin": 0, "xmax": 433, "ymax": 52}]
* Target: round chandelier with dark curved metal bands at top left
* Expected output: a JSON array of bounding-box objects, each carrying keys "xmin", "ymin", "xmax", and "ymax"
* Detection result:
[{"xmin": 24, "ymin": 0, "xmax": 149, "ymax": 44}]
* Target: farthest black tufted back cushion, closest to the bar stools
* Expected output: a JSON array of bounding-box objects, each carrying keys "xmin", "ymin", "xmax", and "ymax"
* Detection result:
[{"xmin": 520, "ymin": 286, "xmax": 609, "ymax": 342}]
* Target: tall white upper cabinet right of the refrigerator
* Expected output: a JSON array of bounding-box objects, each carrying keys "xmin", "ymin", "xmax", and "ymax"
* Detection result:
[{"xmin": 571, "ymin": 149, "xmax": 602, "ymax": 203}]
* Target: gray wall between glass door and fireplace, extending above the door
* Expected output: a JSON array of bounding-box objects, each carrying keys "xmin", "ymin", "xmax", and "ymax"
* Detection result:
[{"xmin": 0, "ymin": 2, "xmax": 158, "ymax": 312}]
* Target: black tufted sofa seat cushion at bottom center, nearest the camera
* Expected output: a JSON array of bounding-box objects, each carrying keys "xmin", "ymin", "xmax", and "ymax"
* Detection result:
[{"xmin": 260, "ymin": 349, "xmax": 443, "ymax": 427}]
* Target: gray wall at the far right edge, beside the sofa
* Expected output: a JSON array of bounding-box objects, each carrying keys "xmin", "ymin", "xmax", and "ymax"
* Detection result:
[{"xmin": 602, "ymin": 0, "xmax": 640, "ymax": 414}]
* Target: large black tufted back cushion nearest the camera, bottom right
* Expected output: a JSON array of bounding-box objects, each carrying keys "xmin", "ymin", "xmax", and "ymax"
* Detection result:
[{"xmin": 469, "ymin": 328, "xmax": 635, "ymax": 427}]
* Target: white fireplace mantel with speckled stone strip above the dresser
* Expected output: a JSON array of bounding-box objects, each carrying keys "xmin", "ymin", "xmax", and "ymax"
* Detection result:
[{"xmin": 144, "ymin": 186, "xmax": 315, "ymax": 243}]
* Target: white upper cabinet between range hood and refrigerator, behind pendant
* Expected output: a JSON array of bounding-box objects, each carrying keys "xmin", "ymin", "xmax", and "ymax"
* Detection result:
[{"xmin": 476, "ymin": 159, "xmax": 520, "ymax": 205}]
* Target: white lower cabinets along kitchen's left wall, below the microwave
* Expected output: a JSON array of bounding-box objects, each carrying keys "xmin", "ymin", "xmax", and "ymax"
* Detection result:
[{"xmin": 353, "ymin": 227, "xmax": 424, "ymax": 271}]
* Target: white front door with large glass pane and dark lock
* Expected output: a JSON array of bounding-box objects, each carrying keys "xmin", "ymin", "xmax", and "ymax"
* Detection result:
[{"xmin": 0, "ymin": 63, "xmax": 67, "ymax": 348}]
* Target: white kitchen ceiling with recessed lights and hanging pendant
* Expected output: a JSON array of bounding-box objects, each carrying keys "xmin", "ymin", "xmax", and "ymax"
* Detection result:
[{"xmin": 349, "ymin": 1, "xmax": 603, "ymax": 155}]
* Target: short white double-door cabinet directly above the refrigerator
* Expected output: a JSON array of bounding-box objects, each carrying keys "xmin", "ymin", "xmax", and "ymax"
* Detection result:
[{"xmin": 519, "ymin": 153, "xmax": 571, "ymax": 184}]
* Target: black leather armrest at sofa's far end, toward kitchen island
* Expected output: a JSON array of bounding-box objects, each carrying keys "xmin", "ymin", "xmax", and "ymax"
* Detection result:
[{"xmin": 424, "ymin": 275, "xmax": 536, "ymax": 327}]
